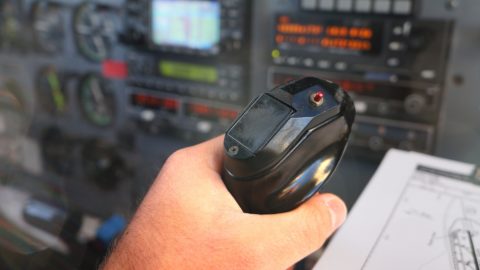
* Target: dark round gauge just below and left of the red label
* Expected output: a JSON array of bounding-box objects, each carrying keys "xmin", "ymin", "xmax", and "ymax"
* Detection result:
[{"xmin": 80, "ymin": 75, "xmax": 116, "ymax": 127}]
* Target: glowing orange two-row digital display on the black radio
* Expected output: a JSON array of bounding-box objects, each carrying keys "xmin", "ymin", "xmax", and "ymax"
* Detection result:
[{"xmin": 275, "ymin": 15, "xmax": 382, "ymax": 54}]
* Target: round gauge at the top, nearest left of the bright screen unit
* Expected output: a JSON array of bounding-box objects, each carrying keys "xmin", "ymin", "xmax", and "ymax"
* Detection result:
[{"xmin": 74, "ymin": 3, "xmax": 115, "ymax": 62}]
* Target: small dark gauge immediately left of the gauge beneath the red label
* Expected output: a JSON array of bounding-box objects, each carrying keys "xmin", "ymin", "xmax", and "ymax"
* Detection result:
[{"xmin": 37, "ymin": 67, "xmax": 67, "ymax": 114}]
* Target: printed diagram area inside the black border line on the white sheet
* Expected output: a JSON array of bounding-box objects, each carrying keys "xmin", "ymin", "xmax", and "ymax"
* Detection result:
[{"xmin": 362, "ymin": 166, "xmax": 480, "ymax": 270}]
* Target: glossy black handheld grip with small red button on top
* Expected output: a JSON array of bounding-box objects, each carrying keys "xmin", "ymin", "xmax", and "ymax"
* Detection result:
[{"xmin": 222, "ymin": 77, "xmax": 355, "ymax": 214}]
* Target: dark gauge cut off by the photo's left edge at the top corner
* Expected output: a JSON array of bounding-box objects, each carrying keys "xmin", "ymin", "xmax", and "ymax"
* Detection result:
[{"xmin": 0, "ymin": 0, "xmax": 21, "ymax": 47}]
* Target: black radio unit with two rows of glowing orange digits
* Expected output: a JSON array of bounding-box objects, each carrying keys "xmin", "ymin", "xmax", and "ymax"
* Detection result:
[{"xmin": 271, "ymin": 13, "xmax": 451, "ymax": 82}]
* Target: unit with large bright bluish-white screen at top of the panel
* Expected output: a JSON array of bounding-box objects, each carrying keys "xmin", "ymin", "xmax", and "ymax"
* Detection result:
[{"xmin": 122, "ymin": 0, "xmax": 249, "ymax": 56}]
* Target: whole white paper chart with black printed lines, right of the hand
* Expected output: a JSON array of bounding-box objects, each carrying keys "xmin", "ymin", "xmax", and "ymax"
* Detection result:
[{"xmin": 315, "ymin": 151, "xmax": 480, "ymax": 270}]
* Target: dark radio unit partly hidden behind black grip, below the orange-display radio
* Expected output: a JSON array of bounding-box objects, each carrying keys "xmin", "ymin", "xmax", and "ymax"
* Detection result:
[{"xmin": 268, "ymin": 67, "xmax": 440, "ymax": 123}]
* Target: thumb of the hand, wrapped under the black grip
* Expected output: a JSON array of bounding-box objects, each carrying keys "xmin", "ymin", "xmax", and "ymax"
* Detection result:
[{"xmin": 251, "ymin": 194, "xmax": 347, "ymax": 267}]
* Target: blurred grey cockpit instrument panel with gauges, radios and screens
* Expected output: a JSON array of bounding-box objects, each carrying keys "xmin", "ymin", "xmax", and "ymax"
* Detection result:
[{"xmin": 0, "ymin": 0, "xmax": 480, "ymax": 269}]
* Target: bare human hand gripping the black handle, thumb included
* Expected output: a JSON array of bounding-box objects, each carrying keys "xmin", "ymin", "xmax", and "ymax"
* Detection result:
[{"xmin": 104, "ymin": 137, "xmax": 347, "ymax": 270}]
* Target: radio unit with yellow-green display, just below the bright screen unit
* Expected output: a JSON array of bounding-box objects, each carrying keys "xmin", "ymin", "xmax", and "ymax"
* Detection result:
[{"xmin": 127, "ymin": 54, "xmax": 246, "ymax": 103}]
